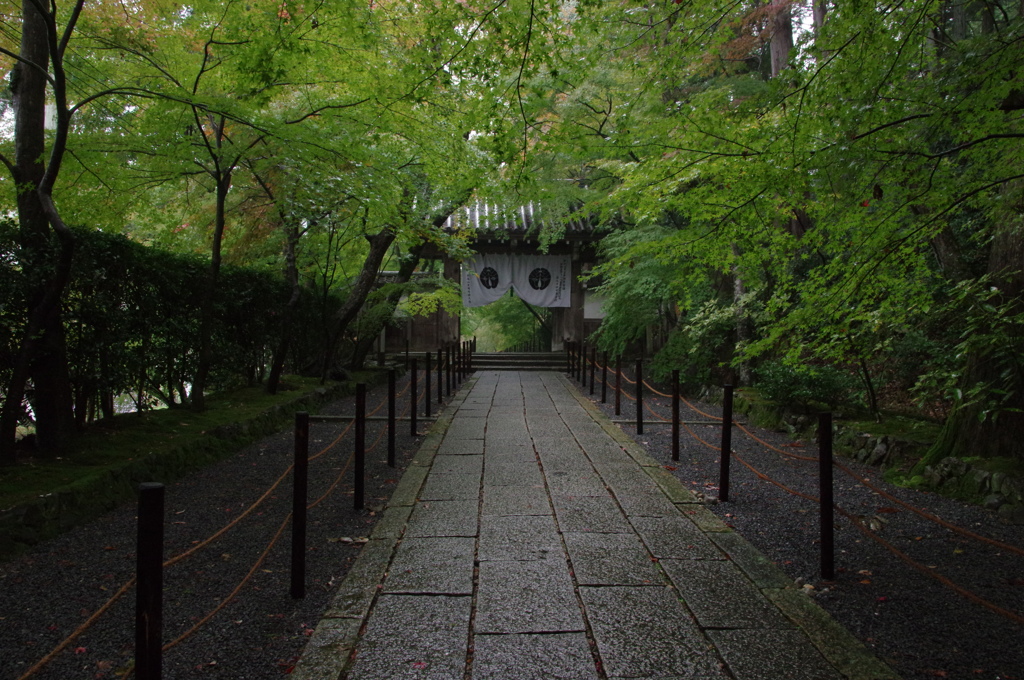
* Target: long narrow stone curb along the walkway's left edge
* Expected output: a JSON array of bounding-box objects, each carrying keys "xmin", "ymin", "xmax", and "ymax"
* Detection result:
[{"xmin": 291, "ymin": 378, "xmax": 476, "ymax": 680}]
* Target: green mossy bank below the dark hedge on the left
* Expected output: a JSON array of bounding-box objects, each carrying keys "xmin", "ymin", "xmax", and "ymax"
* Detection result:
[{"xmin": 0, "ymin": 373, "xmax": 378, "ymax": 558}]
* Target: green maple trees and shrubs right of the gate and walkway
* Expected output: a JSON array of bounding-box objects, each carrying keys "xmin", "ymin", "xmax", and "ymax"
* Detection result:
[{"xmin": 512, "ymin": 0, "xmax": 1024, "ymax": 462}]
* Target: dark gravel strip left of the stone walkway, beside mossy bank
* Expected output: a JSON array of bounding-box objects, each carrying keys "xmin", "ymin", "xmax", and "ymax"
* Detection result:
[{"xmin": 0, "ymin": 375, "xmax": 436, "ymax": 680}]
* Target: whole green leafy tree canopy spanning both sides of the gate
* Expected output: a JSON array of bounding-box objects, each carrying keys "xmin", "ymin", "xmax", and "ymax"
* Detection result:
[{"xmin": 0, "ymin": 0, "xmax": 1024, "ymax": 466}]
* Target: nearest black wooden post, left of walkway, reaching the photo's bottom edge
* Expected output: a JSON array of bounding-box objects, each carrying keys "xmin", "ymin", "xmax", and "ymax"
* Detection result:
[{"xmin": 135, "ymin": 482, "xmax": 164, "ymax": 680}]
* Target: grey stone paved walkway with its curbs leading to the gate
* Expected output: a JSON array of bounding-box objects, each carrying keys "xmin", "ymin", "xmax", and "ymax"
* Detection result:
[{"xmin": 293, "ymin": 372, "xmax": 897, "ymax": 680}]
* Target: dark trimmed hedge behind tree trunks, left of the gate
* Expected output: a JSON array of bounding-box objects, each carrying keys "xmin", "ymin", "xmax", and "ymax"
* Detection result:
[{"xmin": 0, "ymin": 223, "xmax": 338, "ymax": 421}]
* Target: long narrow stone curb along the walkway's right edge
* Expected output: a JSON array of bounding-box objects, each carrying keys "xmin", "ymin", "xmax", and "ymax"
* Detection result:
[{"xmin": 558, "ymin": 374, "xmax": 900, "ymax": 680}]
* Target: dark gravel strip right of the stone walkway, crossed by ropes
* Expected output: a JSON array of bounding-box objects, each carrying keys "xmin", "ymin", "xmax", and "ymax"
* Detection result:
[{"xmin": 583, "ymin": 368, "xmax": 1024, "ymax": 680}]
